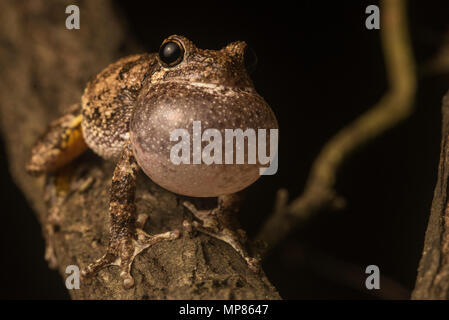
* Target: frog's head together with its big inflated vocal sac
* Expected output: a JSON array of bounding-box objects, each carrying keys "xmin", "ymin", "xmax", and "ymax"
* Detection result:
[{"xmin": 130, "ymin": 35, "xmax": 278, "ymax": 197}]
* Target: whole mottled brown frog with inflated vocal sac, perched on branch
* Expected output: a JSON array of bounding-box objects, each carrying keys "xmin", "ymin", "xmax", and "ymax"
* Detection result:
[{"xmin": 27, "ymin": 35, "xmax": 278, "ymax": 287}]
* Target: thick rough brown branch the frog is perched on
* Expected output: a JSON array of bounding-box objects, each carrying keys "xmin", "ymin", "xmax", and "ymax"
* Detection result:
[{"xmin": 0, "ymin": 0, "xmax": 280, "ymax": 299}]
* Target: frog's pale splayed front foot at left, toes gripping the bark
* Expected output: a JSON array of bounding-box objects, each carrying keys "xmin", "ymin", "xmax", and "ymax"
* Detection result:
[{"xmin": 82, "ymin": 229, "xmax": 180, "ymax": 289}]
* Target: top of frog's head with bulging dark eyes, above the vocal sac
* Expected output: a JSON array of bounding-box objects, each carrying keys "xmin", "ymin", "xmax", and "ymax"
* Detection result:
[{"xmin": 151, "ymin": 35, "xmax": 257, "ymax": 91}]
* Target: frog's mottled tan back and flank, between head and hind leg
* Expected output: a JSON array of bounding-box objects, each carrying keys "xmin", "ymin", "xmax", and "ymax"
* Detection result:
[{"xmin": 81, "ymin": 54, "xmax": 156, "ymax": 159}]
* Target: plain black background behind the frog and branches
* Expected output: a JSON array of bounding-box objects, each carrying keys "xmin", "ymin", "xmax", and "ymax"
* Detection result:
[{"xmin": 0, "ymin": 0, "xmax": 449, "ymax": 299}]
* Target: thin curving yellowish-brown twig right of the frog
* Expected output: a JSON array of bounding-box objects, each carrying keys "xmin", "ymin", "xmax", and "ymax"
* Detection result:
[{"xmin": 257, "ymin": 0, "xmax": 417, "ymax": 255}]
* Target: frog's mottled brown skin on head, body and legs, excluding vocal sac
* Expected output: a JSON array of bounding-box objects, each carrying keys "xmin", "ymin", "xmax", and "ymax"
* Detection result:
[{"xmin": 27, "ymin": 36, "xmax": 277, "ymax": 288}]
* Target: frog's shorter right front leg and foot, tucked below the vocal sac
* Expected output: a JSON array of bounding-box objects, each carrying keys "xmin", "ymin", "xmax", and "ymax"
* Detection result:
[{"xmin": 184, "ymin": 193, "xmax": 260, "ymax": 272}]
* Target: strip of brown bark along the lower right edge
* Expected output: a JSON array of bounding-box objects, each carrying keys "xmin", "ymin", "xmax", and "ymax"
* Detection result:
[{"xmin": 412, "ymin": 94, "xmax": 449, "ymax": 299}]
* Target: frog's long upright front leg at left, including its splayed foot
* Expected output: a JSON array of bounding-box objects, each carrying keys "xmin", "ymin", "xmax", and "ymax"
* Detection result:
[{"xmin": 83, "ymin": 142, "xmax": 180, "ymax": 288}]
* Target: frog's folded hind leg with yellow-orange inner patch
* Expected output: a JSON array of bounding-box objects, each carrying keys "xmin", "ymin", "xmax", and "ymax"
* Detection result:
[{"xmin": 26, "ymin": 104, "xmax": 87, "ymax": 176}]
